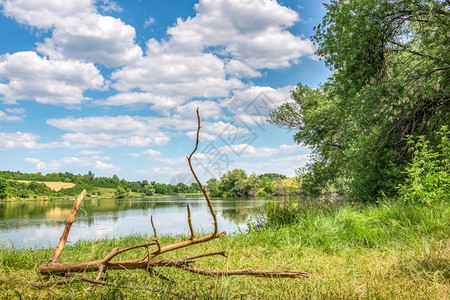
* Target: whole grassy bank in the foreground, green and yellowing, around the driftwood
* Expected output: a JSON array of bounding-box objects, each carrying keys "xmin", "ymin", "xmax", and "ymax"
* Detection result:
[{"xmin": 0, "ymin": 199, "xmax": 450, "ymax": 299}]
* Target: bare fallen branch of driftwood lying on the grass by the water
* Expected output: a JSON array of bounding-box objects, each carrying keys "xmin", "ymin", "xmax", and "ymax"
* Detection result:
[{"xmin": 40, "ymin": 109, "xmax": 309, "ymax": 285}]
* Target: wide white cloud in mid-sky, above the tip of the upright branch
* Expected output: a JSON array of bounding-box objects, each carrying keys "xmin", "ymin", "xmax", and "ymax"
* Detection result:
[{"xmin": 111, "ymin": 49, "xmax": 244, "ymax": 101}]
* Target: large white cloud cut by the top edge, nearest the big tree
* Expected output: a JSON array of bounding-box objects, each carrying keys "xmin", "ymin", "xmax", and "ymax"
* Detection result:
[{"xmin": 168, "ymin": 0, "xmax": 315, "ymax": 69}]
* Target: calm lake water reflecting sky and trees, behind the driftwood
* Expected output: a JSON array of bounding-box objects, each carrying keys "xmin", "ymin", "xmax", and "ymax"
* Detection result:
[{"xmin": 0, "ymin": 197, "xmax": 270, "ymax": 248}]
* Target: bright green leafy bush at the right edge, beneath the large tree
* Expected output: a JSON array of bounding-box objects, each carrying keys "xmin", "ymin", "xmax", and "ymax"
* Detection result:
[{"xmin": 399, "ymin": 126, "xmax": 450, "ymax": 205}]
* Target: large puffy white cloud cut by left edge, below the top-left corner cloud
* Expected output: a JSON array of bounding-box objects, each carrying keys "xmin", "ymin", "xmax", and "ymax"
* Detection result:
[{"xmin": 0, "ymin": 51, "xmax": 104, "ymax": 104}]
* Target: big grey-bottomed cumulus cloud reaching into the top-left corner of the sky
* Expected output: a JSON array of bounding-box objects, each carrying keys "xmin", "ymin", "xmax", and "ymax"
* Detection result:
[{"xmin": 0, "ymin": 0, "xmax": 142, "ymax": 67}]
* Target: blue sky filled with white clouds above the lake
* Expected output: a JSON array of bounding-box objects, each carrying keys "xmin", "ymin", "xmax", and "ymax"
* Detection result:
[{"xmin": 0, "ymin": 0, "xmax": 330, "ymax": 183}]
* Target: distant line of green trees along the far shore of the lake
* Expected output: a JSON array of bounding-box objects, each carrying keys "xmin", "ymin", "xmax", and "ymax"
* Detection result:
[{"xmin": 0, "ymin": 169, "xmax": 286, "ymax": 199}]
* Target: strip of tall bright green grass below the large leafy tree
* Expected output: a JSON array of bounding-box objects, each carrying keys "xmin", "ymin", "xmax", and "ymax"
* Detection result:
[{"xmin": 256, "ymin": 201, "xmax": 450, "ymax": 252}]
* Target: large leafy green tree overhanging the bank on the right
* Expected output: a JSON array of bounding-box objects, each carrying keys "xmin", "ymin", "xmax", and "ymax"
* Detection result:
[{"xmin": 269, "ymin": 0, "xmax": 450, "ymax": 200}]
